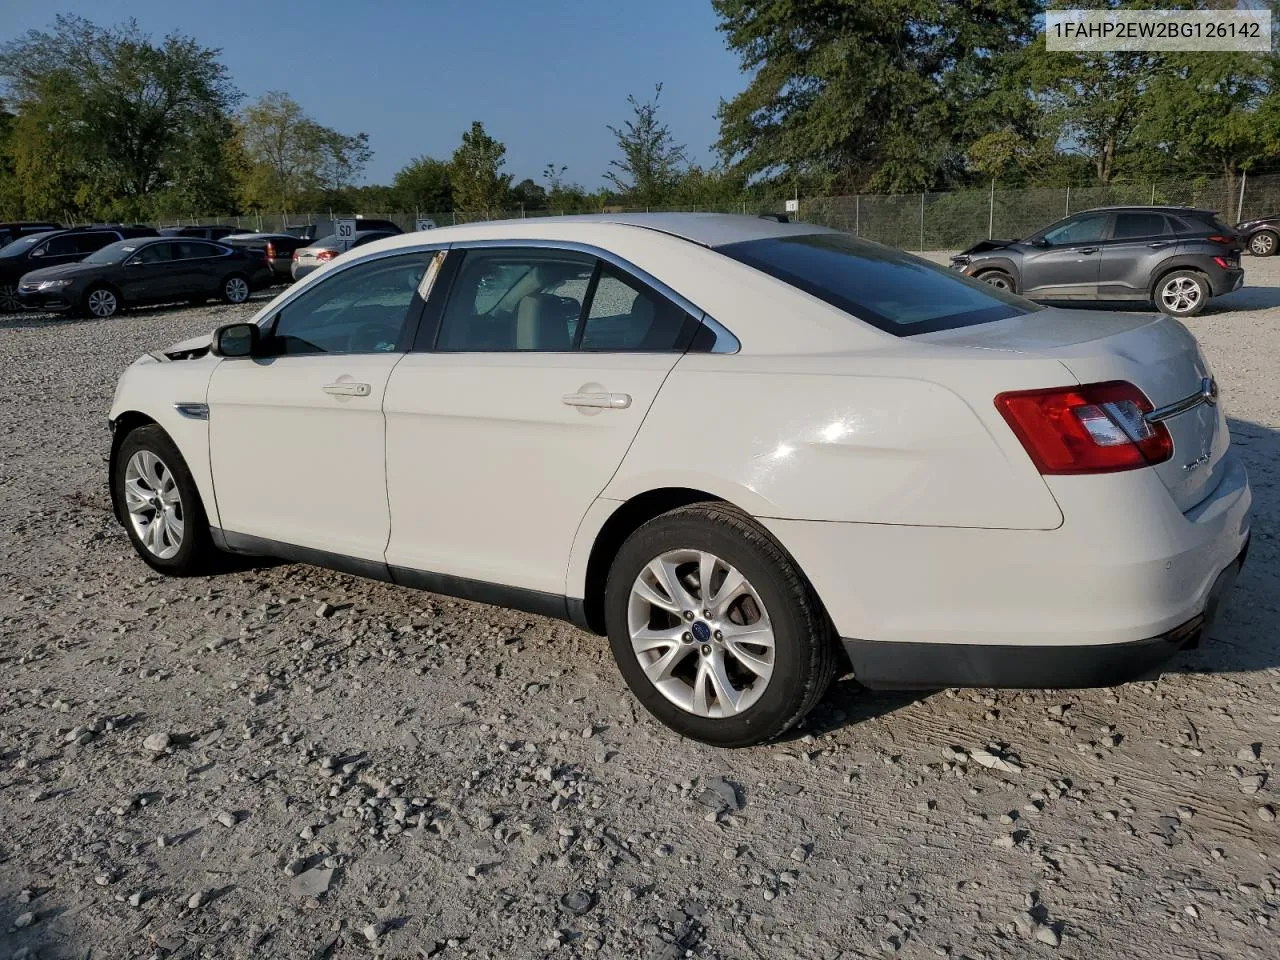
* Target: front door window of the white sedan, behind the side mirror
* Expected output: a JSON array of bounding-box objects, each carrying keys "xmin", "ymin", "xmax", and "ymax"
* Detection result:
[{"xmin": 269, "ymin": 252, "xmax": 431, "ymax": 355}]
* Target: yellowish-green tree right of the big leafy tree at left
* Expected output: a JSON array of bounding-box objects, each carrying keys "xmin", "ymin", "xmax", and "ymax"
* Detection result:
[{"xmin": 238, "ymin": 91, "xmax": 372, "ymax": 211}]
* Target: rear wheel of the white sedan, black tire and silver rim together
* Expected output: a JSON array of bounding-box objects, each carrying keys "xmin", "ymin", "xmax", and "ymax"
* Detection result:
[{"xmin": 604, "ymin": 503, "xmax": 836, "ymax": 748}]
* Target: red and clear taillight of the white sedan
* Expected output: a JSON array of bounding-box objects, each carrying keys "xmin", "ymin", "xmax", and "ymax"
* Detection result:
[{"xmin": 996, "ymin": 380, "xmax": 1174, "ymax": 474}]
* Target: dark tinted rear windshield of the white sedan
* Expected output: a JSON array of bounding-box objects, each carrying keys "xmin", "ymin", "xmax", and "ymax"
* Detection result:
[{"xmin": 717, "ymin": 233, "xmax": 1042, "ymax": 337}]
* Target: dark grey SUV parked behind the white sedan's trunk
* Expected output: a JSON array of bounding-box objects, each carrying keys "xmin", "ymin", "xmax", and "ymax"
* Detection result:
[{"xmin": 951, "ymin": 206, "xmax": 1244, "ymax": 316}]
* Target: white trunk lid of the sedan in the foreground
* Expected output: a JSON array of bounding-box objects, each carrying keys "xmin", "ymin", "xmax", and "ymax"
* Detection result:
[{"xmin": 919, "ymin": 308, "xmax": 1230, "ymax": 513}]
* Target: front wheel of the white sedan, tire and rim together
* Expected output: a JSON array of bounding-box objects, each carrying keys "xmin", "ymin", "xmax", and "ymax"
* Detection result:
[{"xmin": 111, "ymin": 424, "xmax": 218, "ymax": 576}]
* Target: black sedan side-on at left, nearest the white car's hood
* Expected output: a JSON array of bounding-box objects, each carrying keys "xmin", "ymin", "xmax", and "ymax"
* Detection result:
[{"xmin": 18, "ymin": 237, "xmax": 271, "ymax": 319}]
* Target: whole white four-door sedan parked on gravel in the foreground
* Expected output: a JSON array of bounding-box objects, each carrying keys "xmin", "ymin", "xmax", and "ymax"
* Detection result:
[{"xmin": 110, "ymin": 214, "xmax": 1251, "ymax": 746}]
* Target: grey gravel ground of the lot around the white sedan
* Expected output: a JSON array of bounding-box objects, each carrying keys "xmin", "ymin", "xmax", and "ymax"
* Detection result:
[{"xmin": 0, "ymin": 259, "xmax": 1280, "ymax": 960}]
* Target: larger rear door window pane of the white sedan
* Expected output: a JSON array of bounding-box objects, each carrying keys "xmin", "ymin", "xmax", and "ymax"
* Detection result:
[{"xmin": 435, "ymin": 247, "xmax": 595, "ymax": 352}]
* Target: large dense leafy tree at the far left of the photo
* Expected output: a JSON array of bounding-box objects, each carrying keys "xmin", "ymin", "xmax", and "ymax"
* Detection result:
[{"xmin": 0, "ymin": 15, "xmax": 241, "ymax": 216}]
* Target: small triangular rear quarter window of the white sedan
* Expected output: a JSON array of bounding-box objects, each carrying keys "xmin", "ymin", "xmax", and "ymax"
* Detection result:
[{"xmin": 581, "ymin": 264, "xmax": 696, "ymax": 353}]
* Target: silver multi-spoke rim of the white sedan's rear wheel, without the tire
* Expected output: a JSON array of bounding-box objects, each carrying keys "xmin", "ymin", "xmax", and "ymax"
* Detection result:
[{"xmin": 627, "ymin": 549, "xmax": 774, "ymax": 719}]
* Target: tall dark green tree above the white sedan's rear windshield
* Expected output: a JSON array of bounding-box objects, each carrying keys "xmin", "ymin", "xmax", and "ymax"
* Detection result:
[{"xmin": 712, "ymin": 0, "xmax": 1042, "ymax": 192}]
